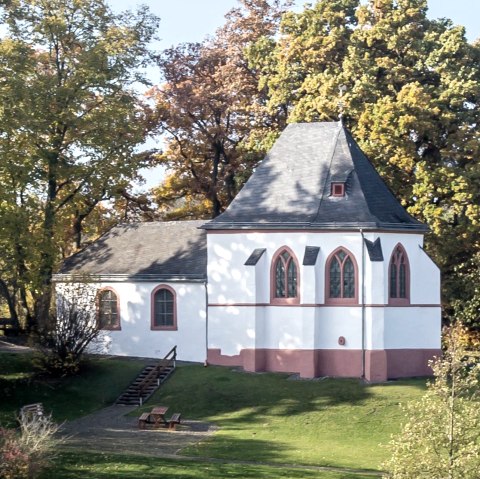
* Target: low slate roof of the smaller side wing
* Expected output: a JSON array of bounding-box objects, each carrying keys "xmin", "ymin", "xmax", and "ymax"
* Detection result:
[{"xmin": 56, "ymin": 221, "xmax": 207, "ymax": 281}]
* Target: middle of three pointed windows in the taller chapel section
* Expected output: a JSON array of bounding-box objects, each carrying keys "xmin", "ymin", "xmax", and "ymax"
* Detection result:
[{"xmin": 325, "ymin": 248, "xmax": 358, "ymax": 304}]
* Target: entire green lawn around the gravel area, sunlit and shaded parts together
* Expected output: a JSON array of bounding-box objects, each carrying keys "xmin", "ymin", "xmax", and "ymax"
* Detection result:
[{"xmin": 0, "ymin": 353, "xmax": 425, "ymax": 479}]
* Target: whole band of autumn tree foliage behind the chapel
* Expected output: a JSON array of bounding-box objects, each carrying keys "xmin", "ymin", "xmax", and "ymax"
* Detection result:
[{"xmin": 0, "ymin": 0, "xmax": 480, "ymax": 327}]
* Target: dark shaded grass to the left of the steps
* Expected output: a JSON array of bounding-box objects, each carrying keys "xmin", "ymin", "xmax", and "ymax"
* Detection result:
[{"xmin": 0, "ymin": 353, "xmax": 150, "ymax": 426}]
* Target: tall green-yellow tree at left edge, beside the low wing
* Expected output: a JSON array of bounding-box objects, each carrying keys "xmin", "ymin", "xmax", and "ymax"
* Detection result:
[{"xmin": 0, "ymin": 0, "xmax": 158, "ymax": 325}]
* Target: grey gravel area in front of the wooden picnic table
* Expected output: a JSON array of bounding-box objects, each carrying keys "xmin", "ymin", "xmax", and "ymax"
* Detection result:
[{"xmin": 61, "ymin": 406, "xmax": 216, "ymax": 457}]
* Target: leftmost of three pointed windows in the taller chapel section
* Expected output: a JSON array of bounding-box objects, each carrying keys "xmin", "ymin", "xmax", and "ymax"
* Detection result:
[{"xmin": 271, "ymin": 247, "xmax": 299, "ymax": 304}]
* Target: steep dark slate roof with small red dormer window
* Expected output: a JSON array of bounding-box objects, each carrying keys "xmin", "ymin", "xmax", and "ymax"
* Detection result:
[{"xmin": 203, "ymin": 122, "xmax": 427, "ymax": 231}]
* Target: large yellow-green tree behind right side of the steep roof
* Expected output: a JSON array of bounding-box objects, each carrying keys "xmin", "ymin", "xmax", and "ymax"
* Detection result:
[{"xmin": 249, "ymin": 0, "xmax": 480, "ymax": 321}]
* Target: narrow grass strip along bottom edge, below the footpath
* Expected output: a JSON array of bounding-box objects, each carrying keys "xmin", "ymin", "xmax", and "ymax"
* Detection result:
[{"xmin": 42, "ymin": 454, "xmax": 378, "ymax": 479}]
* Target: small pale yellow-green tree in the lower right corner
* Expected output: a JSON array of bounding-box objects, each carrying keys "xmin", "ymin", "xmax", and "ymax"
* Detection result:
[{"xmin": 384, "ymin": 325, "xmax": 480, "ymax": 479}]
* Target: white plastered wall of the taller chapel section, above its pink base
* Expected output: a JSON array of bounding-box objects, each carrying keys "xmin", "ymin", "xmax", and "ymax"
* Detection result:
[{"xmin": 207, "ymin": 232, "xmax": 440, "ymax": 355}]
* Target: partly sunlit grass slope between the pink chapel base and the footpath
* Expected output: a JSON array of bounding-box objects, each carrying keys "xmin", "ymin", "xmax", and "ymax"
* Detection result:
[{"xmin": 141, "ymin": 366, "xmax": 425, "ymax": 469}]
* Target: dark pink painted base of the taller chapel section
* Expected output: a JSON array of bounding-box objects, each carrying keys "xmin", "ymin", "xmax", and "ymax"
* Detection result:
[{"xmin": 208, "ymin": 349, "xmax": 441, "ymax": 382}]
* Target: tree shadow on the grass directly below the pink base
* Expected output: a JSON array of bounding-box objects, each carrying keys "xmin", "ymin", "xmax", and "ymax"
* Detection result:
[{"xmin": 143, "ymin": 365, "xmax": 371, "ymax": 423}]
